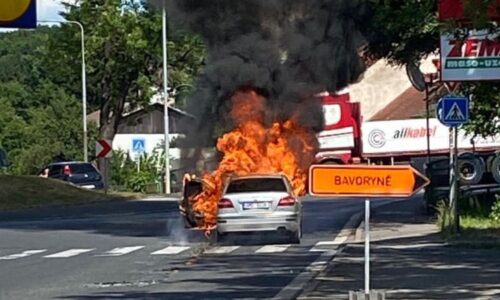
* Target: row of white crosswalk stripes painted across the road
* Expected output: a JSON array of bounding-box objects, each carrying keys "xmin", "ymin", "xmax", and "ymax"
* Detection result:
[{"xmin": 0, "ymin": 241, "xmax": 338, "ymax": 263}]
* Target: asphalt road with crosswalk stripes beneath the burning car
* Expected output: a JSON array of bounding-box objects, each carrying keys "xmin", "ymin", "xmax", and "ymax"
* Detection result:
[{"xmin": 0, "ymin": 198, "xmax": 390, "ymax": 300}]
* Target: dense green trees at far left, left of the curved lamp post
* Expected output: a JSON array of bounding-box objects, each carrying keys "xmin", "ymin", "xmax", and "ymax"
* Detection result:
[{"xmin": 0, "ymin": 27, "xmax": 95, "ymax": 174}]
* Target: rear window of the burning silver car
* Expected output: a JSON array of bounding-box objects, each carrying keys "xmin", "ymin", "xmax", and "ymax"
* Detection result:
[{"xmin": 226, "ymin": 178, "xmax": 287, "ymax": 194}]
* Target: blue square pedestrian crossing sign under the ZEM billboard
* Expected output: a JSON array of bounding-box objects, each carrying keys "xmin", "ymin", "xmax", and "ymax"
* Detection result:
[{"xmin": 437, "ymin": 96, "xmax": 469, "ymax": 127}]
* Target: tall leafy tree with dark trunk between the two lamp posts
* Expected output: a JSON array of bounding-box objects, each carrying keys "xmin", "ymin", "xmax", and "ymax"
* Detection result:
[{"xmin": 51, "ymin": 0, "xmax": 204, "ymax": 144}]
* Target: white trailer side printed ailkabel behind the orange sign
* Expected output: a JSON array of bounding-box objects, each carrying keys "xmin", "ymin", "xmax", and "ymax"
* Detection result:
[{"xmin": 363, "ymin": 118, "xmax": 500, "ymax": 157}]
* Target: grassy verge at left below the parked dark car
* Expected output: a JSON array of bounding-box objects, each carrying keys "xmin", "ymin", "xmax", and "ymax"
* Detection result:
[{"xmin": 0, "ymin": 175, "xmax": 137, "ymax": 211}]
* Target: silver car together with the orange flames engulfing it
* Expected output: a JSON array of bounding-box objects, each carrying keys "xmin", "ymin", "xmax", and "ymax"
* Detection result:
[{"xmin": 180, "ymin": 90, "xmax": 316, "ymax": 242}]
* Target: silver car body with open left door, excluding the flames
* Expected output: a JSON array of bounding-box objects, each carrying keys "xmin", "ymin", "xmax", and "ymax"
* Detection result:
[{"xmin": 181, "ymin": 174, "xmax": 302, "ymax": 243}]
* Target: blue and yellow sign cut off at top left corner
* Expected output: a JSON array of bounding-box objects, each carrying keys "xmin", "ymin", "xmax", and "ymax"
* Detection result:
[{"xmin": 0, "ymin": 0, "xmax": 36, "ymax": 28}]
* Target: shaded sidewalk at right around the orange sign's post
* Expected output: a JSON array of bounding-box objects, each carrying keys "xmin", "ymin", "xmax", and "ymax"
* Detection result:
[{"xmin": 298, "ymin": 199, "xmax": 500, "ymax": 300}]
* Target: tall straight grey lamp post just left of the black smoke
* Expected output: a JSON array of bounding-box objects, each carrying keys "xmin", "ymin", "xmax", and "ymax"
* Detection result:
[{"xmin": 162, "ymin": 0, "xmax": 170, "ymax": 194}]
